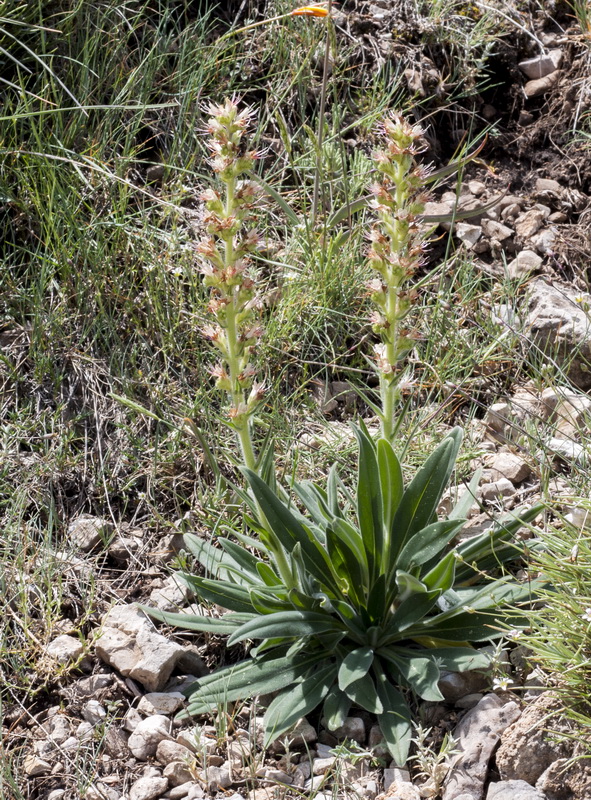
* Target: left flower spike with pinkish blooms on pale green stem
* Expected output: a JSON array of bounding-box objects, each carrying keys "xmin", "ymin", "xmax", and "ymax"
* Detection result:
[{"xmin": 197, "ymin": 99, "xmax": 264, "ymax": 468}]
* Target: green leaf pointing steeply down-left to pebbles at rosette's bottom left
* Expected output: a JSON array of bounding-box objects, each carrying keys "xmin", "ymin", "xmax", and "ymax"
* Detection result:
[{"xmin": 263, "ymin": 664, "xmax": 337, "ymax": 747}]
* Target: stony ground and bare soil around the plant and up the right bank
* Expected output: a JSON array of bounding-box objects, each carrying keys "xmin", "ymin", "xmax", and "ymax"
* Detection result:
[{"xmin": 3, "ymin": 0, "xmax": 591, "ymax": 800}]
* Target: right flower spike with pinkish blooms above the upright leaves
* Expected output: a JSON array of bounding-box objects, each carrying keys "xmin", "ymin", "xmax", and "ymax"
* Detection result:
[{"xmin": 367, "ymin": 114, "xmax": 429, "ymax": 438}]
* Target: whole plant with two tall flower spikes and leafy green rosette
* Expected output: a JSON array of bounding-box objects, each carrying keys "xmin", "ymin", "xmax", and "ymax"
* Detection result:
[{"xmin": 145, "ymin": 101, "xmax": 539, "ymax": 765}]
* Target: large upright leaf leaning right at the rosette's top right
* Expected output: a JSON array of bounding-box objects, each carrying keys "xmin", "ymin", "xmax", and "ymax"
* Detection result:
[{"xmin": 392, "ymin": 428, "xmax": 462, "ymax": 562}]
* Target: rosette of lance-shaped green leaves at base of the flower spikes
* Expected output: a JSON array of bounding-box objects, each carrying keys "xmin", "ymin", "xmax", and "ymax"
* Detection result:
[{"xmin": 144, "ymin": 428, "xmax": 540, "ymax": 765}]
